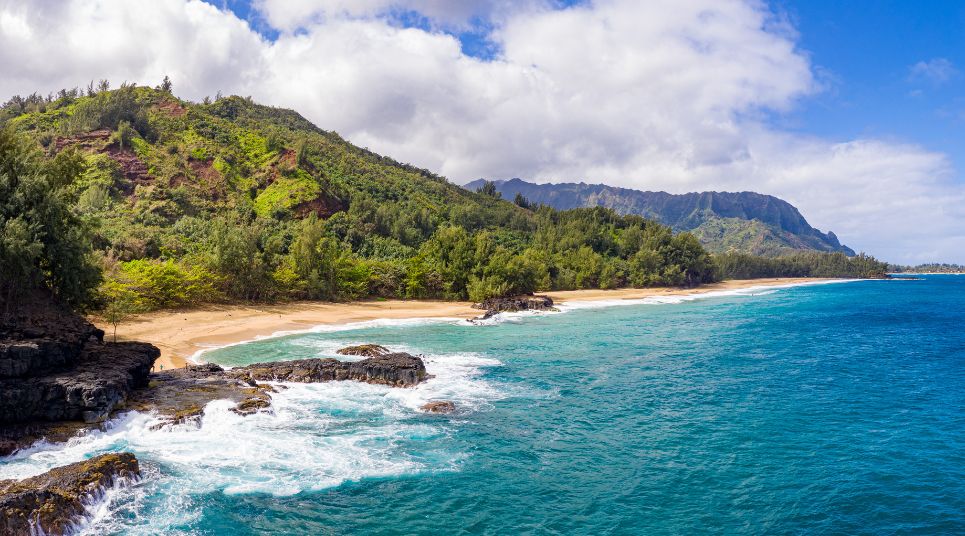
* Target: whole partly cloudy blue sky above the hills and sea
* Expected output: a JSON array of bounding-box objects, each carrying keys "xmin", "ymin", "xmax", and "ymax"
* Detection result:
[{"xmin": 0, "ymin": 0, "xmax": 965, "ymax": 264}]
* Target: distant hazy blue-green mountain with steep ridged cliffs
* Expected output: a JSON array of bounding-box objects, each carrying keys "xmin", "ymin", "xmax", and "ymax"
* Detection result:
[{"xmin": 465, "ymin": 179, "xmax": 854, "ymax": 255}]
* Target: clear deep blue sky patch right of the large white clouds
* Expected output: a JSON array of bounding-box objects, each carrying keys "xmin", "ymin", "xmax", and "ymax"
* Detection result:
[{"xmin": 775, "ymin": 0, "xmax": 965, "ymax": 180}]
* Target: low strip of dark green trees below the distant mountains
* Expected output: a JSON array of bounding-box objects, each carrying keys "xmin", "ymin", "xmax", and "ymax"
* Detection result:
[{"xmin": 714, "ymin": 252, "xmax": 888, "ymax": 279}]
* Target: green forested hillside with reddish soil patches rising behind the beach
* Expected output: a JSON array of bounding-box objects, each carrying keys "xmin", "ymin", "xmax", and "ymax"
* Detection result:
[{"xmin": 0, "ymin": 80, "xmax": 884, "ymax": 310}]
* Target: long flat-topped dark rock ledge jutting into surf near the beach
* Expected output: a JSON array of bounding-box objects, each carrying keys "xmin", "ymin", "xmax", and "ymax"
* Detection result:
[{"xmin": 227, "ymin": 352, "xmax": 427, "ymax": 387}]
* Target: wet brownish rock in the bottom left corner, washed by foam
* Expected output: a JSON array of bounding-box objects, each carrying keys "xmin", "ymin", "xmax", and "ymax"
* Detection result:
[{"xmin": 0, "ymin": 453, "xmax": 141, "ymax": 536}]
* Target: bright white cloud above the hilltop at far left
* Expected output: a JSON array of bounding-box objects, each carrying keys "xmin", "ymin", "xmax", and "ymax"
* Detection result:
[{"xmin": 0, "ymin": 0, "xmax": 267, "ymax": 98}]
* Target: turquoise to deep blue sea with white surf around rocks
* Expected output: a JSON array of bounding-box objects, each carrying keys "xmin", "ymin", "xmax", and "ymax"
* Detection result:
[{"xmin": 0, "ymin": 276, "xmax": 965, "ymax": 535}]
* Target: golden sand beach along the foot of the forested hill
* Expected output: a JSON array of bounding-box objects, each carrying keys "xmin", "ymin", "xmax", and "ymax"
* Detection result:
[{"xmin": 92, "ymin": 277, "xmax": 836, "ymax": 369}]
